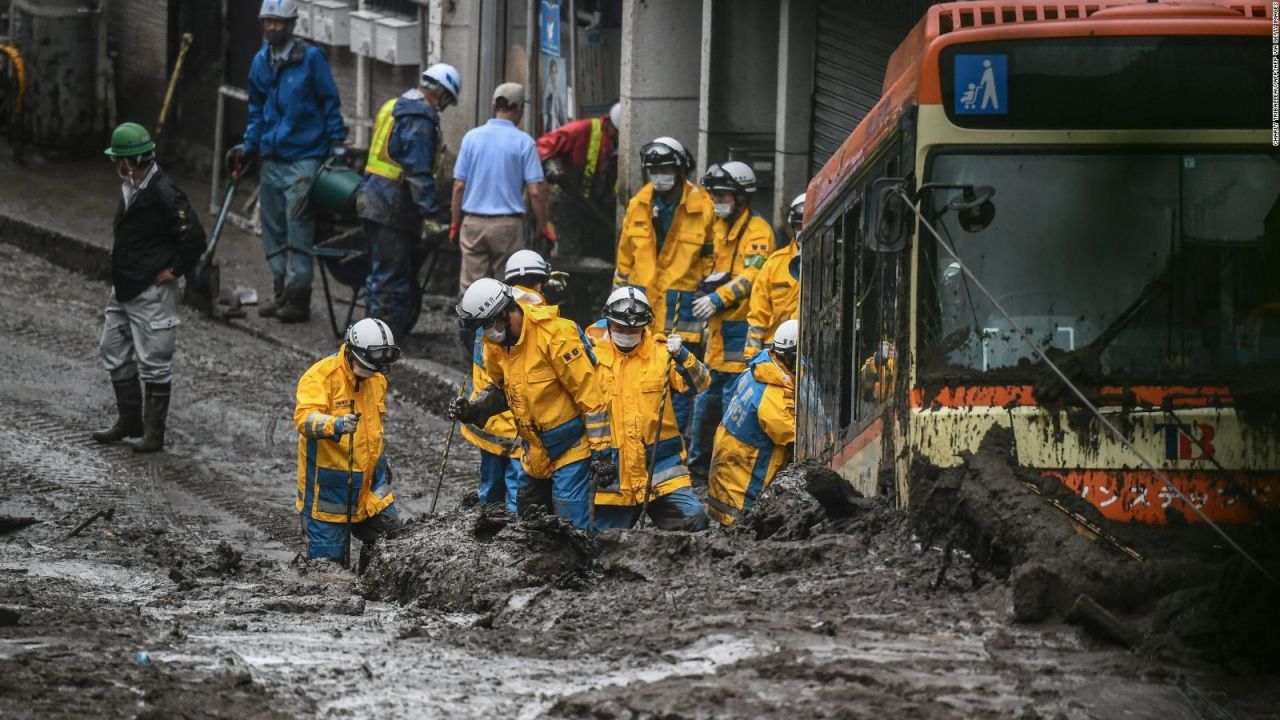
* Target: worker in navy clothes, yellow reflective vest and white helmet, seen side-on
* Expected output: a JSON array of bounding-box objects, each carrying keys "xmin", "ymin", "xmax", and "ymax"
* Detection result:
[{"xmin": 356, "ymin": 63, "xmax": 462, "ymax": 337}]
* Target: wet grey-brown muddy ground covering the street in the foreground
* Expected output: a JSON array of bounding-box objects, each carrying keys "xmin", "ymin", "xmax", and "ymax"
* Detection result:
[{"xmin": 0, "ymin": 245, "xmax": 1280, "ymax": 719}]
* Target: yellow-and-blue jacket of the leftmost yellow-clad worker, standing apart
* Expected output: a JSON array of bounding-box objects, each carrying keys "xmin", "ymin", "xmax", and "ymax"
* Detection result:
[{"xmin": 293, "ymin": 345, "xmax": 394, "ymax": 523}]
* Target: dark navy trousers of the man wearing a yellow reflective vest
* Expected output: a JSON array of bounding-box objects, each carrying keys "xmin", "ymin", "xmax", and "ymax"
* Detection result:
[{"xmin": 362, "ymin": 220, "xmax": 426, "ymax": 338}]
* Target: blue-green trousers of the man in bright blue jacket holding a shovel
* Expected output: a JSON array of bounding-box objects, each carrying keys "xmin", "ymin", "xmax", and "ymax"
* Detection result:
[{"xmin": 259, "ymin": 159, "xmax": 320, "ymax": 292}]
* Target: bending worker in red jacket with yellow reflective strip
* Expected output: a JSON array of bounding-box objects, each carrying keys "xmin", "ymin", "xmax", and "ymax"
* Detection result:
[{"xmin": 538, "ymin": 102, "xmax": 622, "ymax": 256}]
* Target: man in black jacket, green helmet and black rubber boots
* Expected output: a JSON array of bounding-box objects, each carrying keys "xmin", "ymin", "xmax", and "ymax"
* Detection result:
[{"xmin": 93, "ymin": 123, "xmax": 205, "ymax": 452}]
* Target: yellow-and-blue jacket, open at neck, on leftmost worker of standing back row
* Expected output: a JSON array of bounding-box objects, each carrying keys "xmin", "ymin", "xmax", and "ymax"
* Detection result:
[{"xmin": 613, "ymin": 181, "xmax": 716, "ymax": 343}]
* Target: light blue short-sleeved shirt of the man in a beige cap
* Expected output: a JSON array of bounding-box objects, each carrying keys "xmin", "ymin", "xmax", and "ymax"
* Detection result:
[{"xmin": 453, "ymin": 118, "xmax": 543, "ymax": 215}]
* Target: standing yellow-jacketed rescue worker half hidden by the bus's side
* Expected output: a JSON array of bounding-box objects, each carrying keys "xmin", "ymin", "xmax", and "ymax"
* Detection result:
[{"xmin": 745, "ymin": 195, "xmax": 804, "ymax": 360}]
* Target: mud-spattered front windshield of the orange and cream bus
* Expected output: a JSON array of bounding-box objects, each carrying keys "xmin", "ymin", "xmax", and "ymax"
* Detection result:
[{"xmin": 919, "ymin": 151, "xmax": 1280, "ymax": 382}]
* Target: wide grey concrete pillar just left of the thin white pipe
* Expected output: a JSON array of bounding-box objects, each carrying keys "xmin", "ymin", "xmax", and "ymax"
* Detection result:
[{"xmin": 618, "ymin": 0, "xmax": 703, "ymax": 202}]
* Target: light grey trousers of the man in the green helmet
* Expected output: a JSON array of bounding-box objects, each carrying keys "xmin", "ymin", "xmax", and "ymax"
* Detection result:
[{"xmin": 99, "ymin": 282, "xmax": 178, "ymax": 383}]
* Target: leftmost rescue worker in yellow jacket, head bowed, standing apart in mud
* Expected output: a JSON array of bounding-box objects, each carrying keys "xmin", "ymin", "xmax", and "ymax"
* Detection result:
[{"xmin": 293, "ymin": 318, "xmax": 399, "ymax": 570}]
